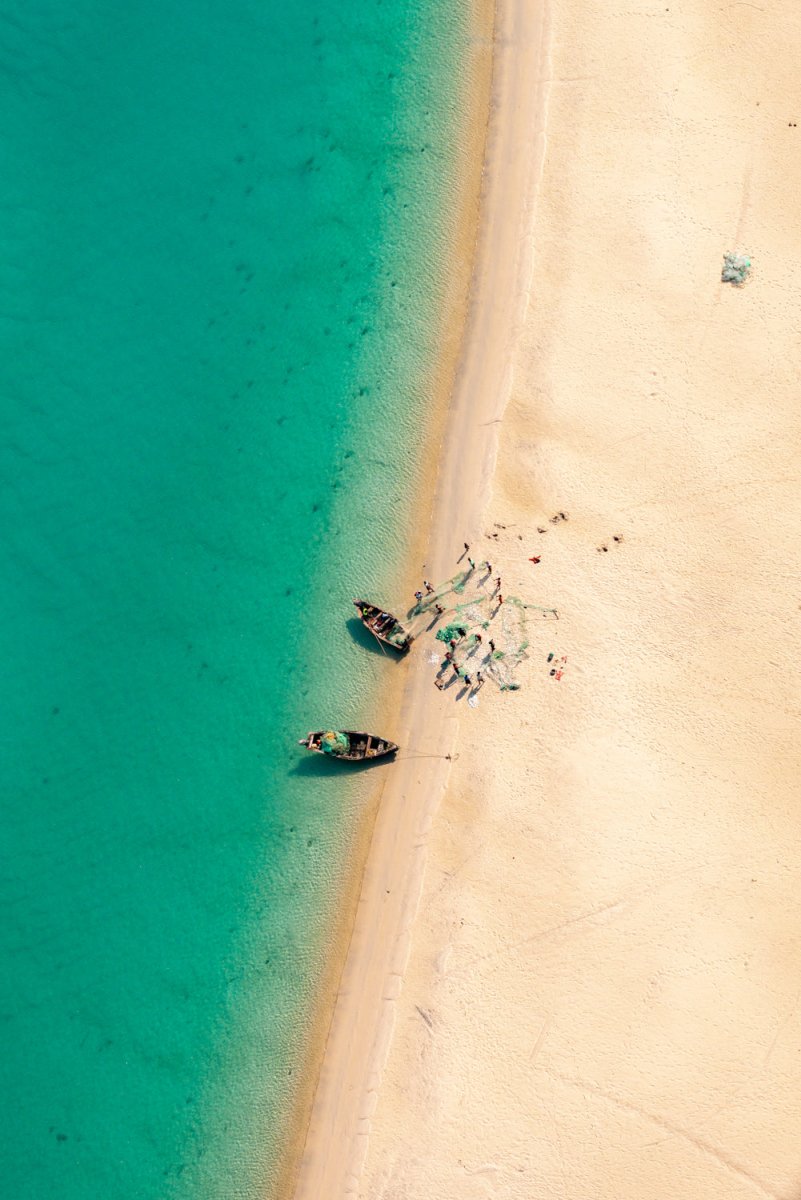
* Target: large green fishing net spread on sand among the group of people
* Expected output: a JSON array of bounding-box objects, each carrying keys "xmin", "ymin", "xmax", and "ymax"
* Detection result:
[{"xmin": 406, "ymin": 566, "xmax": 559, "ymax": 691}]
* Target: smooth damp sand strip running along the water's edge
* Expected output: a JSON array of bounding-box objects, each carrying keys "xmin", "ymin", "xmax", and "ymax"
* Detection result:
[{"xmin": 282, "ymin": 0, "xmax": 549, "ymax": 1200}]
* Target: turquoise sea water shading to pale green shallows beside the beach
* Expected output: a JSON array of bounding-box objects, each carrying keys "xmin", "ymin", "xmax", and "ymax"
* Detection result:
[{"xmin": 0, "ymin": 0, "xmax": 466, "ymax": 1200}]
